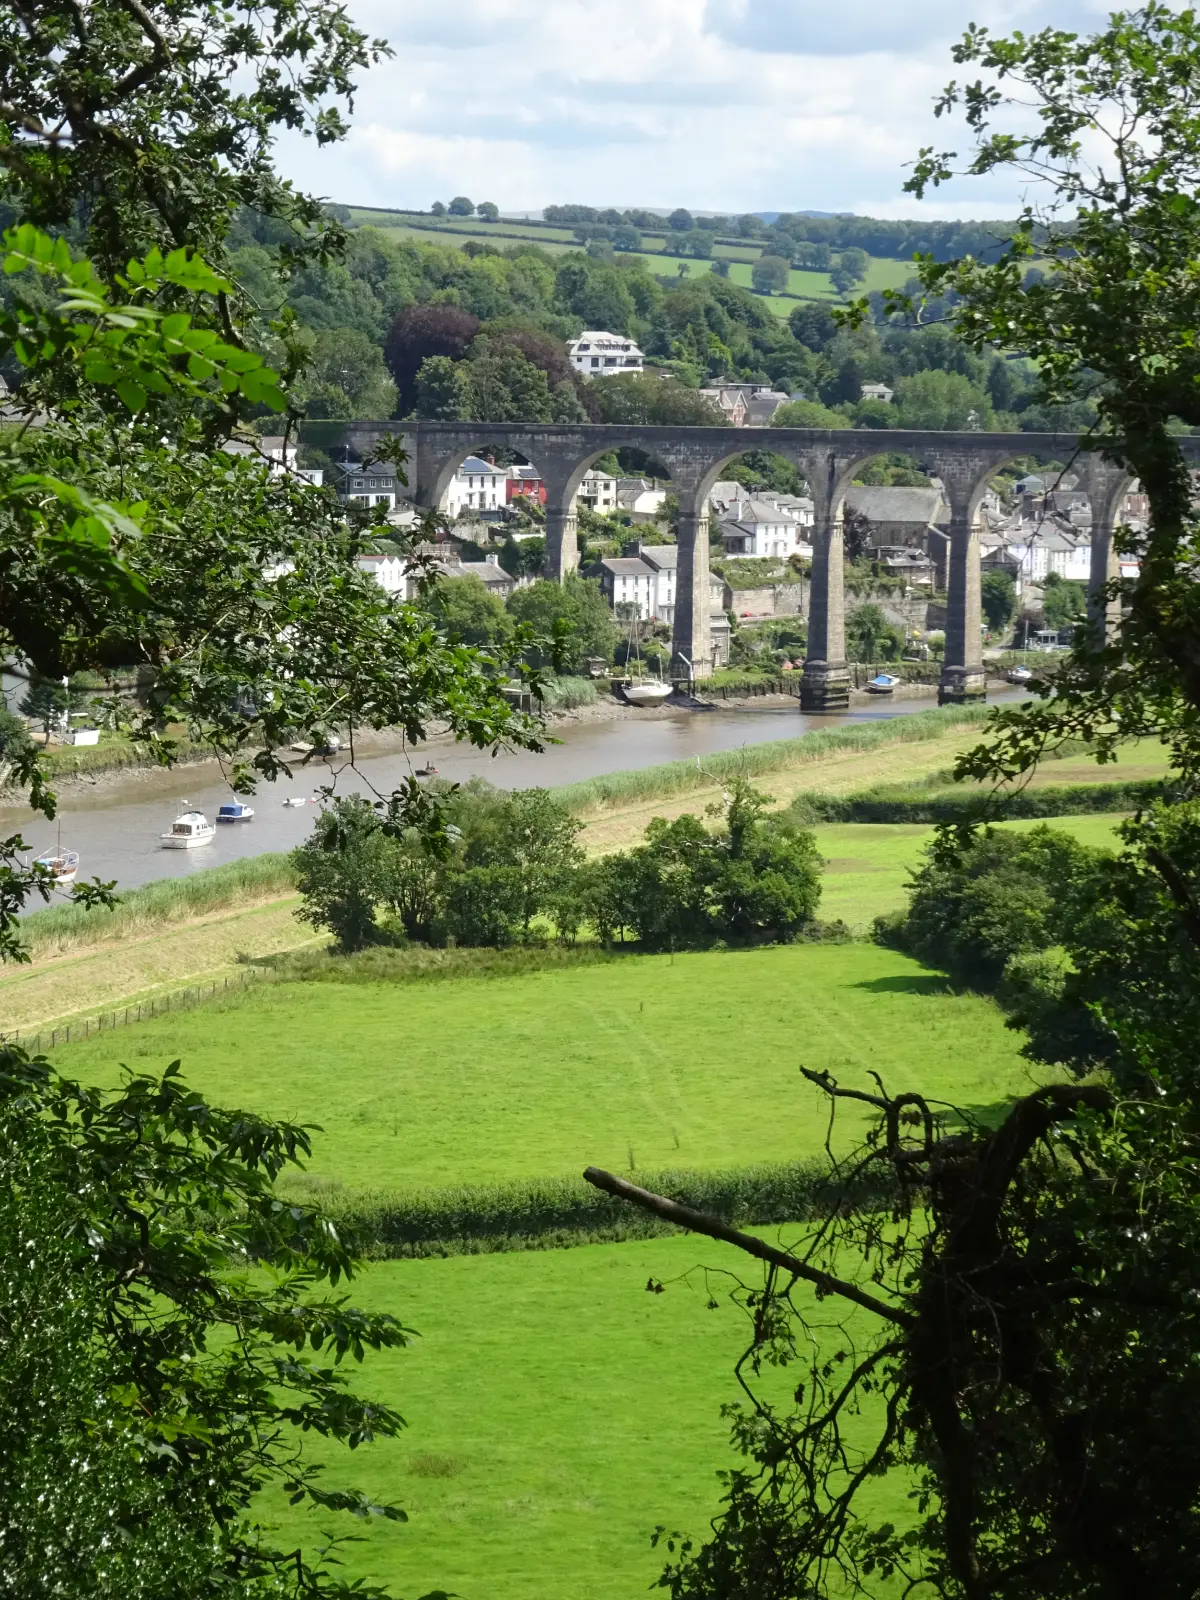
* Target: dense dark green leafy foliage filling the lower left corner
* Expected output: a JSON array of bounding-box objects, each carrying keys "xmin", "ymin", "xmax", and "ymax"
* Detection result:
[{"xmin": 0, "ymin": 1048, "xmax": 448, "ymax": 1600}]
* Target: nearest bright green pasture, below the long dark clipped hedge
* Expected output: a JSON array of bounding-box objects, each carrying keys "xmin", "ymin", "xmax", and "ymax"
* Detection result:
[{"xmin": 264, "ymin": 1229, "xmax": 909, "ymax": 1600}]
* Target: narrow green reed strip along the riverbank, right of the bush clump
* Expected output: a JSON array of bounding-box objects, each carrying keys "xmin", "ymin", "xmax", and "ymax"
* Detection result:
[{"xmin": 554, "ymin": 706, "xmax": 989, "ymax": 813}]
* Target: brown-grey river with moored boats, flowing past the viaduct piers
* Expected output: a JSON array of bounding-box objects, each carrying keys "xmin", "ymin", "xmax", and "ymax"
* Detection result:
[{"xmin": 0, "ymin": 693, "xmax": 1010, "ymax": 888}]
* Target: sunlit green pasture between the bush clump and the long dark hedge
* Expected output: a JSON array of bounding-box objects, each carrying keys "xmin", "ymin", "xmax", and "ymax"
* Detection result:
[{"xmin": 58, "ymin": 940, "xmax": 1029, "ymax": 1190}]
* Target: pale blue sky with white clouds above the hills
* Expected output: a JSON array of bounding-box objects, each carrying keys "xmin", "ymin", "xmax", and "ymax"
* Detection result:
[{"xmin": 278, "ymin": 0, "xmax": 1126, "ymax": 218}]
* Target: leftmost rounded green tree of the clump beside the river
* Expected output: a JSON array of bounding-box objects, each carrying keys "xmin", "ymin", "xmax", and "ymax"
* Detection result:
[{"xmin": 291, "ymin": 795, "xmax": 398, "ymax": 950}]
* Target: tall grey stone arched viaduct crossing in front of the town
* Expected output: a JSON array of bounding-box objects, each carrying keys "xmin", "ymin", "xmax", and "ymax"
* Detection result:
[{"xmin": 342, "ymin": 422, "xmax": 1200, "ymax": 712}]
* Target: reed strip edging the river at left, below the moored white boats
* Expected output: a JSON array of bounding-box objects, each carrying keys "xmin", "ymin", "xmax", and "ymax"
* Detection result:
[{"xmin": 21, "ymin": 853, "xmax": 296, "ymax": 955}]
